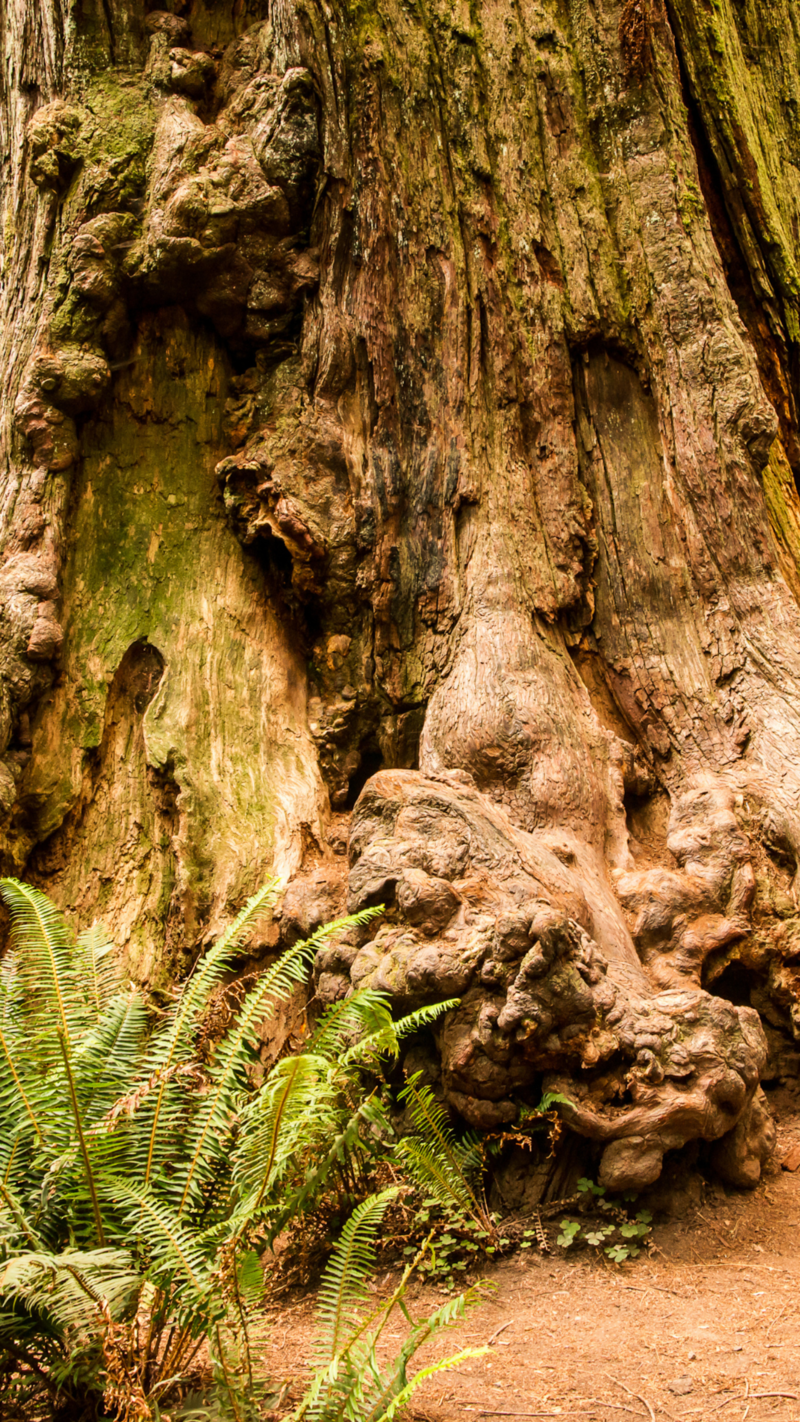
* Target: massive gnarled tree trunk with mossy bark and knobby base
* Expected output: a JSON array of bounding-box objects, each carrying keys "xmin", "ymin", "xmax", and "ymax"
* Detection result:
[{"xmin": 0, "ymin": 0, "xmax": 800, "ymax": 1189}]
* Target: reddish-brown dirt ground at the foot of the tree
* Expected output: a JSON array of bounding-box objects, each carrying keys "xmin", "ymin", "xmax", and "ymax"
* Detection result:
[{"xmin": 260, "ymin": 1088, "xmax": 800, "ymax": 1422}]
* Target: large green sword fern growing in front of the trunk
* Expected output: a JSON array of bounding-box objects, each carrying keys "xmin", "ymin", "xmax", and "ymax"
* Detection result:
[{"xmin": 0, "ymin": 879, "xmax": 485, "ymax": 1422}]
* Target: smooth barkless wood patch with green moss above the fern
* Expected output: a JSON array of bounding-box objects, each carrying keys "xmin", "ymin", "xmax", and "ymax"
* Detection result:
[{"xmin": 26, "ymin": 316, "xmax": 325, "ymax": 977}]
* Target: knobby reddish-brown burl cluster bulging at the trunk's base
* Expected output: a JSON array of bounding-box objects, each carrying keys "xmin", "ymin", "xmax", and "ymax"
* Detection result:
[{"xmin": 309, "ymin": 771, "xmax": 774, "ymax": 1189}]
